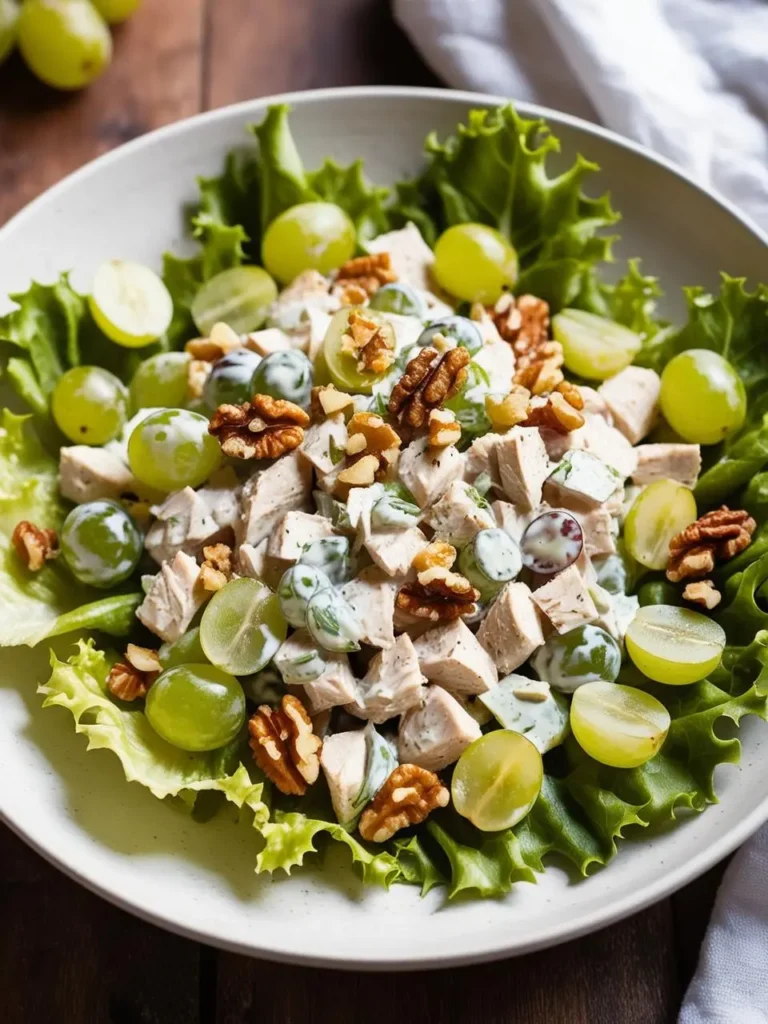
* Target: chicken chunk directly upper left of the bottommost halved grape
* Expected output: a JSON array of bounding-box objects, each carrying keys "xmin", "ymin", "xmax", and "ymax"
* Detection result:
[{"xmin": 397, "ymin": 686, "xmax": 481, "ymax": 771}]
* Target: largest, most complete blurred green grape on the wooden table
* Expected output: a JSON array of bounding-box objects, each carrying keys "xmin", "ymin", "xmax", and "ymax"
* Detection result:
[{"xmin": 18, "ymin": 0, "xmax": 112, "ymax": 89}]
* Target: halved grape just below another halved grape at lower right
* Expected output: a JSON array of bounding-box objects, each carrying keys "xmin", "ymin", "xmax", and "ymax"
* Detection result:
[{"xmin": 570, "ymin": 683, "xmax": 670, "ymax": 768}]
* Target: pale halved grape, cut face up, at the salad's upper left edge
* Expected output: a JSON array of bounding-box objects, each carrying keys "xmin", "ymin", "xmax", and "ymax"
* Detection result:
[{"xmin": 88, "ymin": 259, "xmax": 173, "ymax": 348}]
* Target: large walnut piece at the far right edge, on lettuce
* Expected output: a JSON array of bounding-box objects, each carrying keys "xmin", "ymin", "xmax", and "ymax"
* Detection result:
[{"xmin": 667, "ymin": 505, "xmax": 757, "ymax": 583}]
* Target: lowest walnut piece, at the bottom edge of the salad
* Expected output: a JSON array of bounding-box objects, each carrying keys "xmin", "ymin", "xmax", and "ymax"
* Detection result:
[{"xmin": 359, "ymin": 765, "xmax": 451, "ymax": 843}]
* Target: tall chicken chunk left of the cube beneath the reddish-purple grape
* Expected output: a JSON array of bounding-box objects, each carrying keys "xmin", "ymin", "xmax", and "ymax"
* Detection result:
[{"xmin": 477, "ymin": 583, "xmax": 544, "ymax": 676}]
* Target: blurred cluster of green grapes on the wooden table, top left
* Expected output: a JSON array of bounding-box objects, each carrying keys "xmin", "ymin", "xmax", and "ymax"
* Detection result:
[{"xmin": 0, "ymin": 0, "xmax": 141, "ymax": 90}]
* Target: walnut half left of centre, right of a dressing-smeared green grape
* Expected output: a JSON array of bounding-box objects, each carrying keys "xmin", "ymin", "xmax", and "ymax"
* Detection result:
[{"xmin": 208, "ymin": 394, "xmax": 309, "ymax": 459}]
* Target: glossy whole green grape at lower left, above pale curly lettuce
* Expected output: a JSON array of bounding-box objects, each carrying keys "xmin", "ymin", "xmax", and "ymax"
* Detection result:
[{"xmin": 144, "ymin": 665, "xmax": 246, "ymax": 753}]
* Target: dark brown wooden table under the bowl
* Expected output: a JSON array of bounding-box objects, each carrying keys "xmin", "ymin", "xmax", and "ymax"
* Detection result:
[{"xmin": 0, "ymin": 0, "xmax": 720, "ymax": 1024}]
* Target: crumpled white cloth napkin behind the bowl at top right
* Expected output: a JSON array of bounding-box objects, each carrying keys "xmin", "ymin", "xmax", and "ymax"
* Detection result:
[{"xmin": 393, "ymin": 0, "xmax": 768, "ymax": 228}]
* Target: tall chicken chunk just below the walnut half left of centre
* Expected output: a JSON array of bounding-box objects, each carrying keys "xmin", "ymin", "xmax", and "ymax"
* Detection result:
[{"xmin": 237, "ymin": 452, "xmax": 312, "ymax": 545}]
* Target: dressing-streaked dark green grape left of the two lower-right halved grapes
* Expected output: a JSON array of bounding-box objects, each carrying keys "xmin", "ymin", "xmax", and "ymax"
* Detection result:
[{"xmin": 530, "ymin": 624, "xmax": 622, "ymax": 693}]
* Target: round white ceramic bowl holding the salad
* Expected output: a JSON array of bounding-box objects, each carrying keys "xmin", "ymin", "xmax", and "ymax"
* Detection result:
[{"xmin": 0, "ymin": 88, "xmax": 768, "ymax": 968}]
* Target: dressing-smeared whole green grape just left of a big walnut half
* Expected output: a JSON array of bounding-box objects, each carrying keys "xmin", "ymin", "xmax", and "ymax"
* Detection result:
[{"xmin": 128, "ymin": 409, "xmax": 221, "ymax": 492}]
